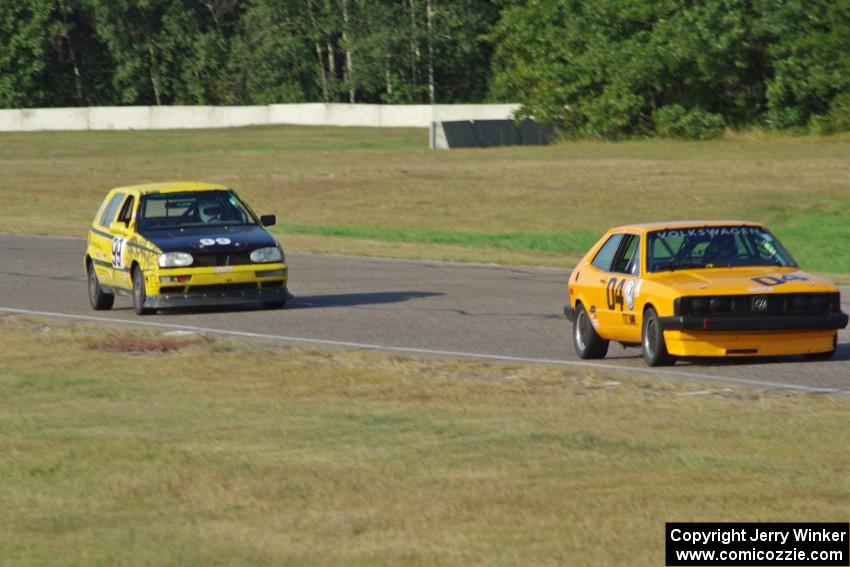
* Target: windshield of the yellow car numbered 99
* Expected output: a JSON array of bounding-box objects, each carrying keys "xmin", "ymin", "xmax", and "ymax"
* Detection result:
[{"xmin": 139, "ymin": 190, "xmax": 257, "ymax": 230}]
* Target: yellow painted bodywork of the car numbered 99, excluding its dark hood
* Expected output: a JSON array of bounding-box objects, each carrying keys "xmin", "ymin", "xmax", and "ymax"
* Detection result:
[{"xmin": 84, "ymin": 182, "xmax": 289, "ymax": 308}]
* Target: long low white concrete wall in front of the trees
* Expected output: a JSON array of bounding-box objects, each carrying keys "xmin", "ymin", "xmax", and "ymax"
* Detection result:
[{"xmin": 0, "ymin": 103, "xmax": 519, "ymax": 132}]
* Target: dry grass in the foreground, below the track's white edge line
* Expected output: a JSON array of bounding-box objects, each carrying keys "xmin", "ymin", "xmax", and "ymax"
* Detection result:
[{"xmin": 0, "ymin": 316, "xmax": 850, "ymax": 567}]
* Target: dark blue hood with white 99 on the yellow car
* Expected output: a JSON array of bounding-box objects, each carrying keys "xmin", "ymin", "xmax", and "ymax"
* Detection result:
[{"xmin": 141, "ymin": 226, "xmax": 277, "ymax": 253}]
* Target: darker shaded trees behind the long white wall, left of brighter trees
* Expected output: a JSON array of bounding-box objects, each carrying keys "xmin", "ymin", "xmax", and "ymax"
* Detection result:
[{"xmin": 0, "ymin": 0, "xmax": 498, "ymax": 108}]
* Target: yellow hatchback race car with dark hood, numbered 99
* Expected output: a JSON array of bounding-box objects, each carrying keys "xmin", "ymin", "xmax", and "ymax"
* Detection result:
[{"xmin": 84, "ymin": 182, "xmax": 288, "ymax": 315}]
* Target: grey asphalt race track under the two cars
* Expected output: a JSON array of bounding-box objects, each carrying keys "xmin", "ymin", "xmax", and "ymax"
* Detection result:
[{"xmin": 0, "ymin": 234, "xmax": 850, "ymax": 394}]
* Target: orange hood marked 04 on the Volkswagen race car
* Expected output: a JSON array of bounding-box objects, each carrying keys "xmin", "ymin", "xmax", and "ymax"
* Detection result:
[{"xmin": 651, "ymin": 266, "xmax": 838, "ymax": 295}]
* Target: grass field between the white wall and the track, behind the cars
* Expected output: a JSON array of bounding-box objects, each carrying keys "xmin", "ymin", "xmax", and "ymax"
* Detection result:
[{"xmin": 0, "ymin": 127, "xmax": 850, "ymax": 274}]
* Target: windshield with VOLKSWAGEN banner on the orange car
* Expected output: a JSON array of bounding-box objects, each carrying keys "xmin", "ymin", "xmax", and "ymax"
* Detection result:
[{"xmin": 646, "ymin": 226, "xmax": 796, "ymax": 272}]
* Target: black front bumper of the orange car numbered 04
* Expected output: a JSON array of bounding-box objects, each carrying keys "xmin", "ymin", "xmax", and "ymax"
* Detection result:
[{"xmin": 659, "ymin": 312, "xmax": 848, "ymax": 331}]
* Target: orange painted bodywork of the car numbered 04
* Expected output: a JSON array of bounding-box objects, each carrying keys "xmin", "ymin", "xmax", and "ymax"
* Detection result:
[{"xmin": 565, "ymin": 220, "xmax": 847, "ymax": 358}]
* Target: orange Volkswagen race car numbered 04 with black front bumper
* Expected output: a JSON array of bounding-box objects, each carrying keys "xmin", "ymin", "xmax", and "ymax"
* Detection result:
[{"xmin": 564, "ymin": 221, "xmax": 848, "ymax": 366}]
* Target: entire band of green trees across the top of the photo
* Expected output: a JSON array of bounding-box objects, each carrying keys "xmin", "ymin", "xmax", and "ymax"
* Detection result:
[{"xmin": 0, "ymin": 0, "xmax": 850, "ymax": 139}]
